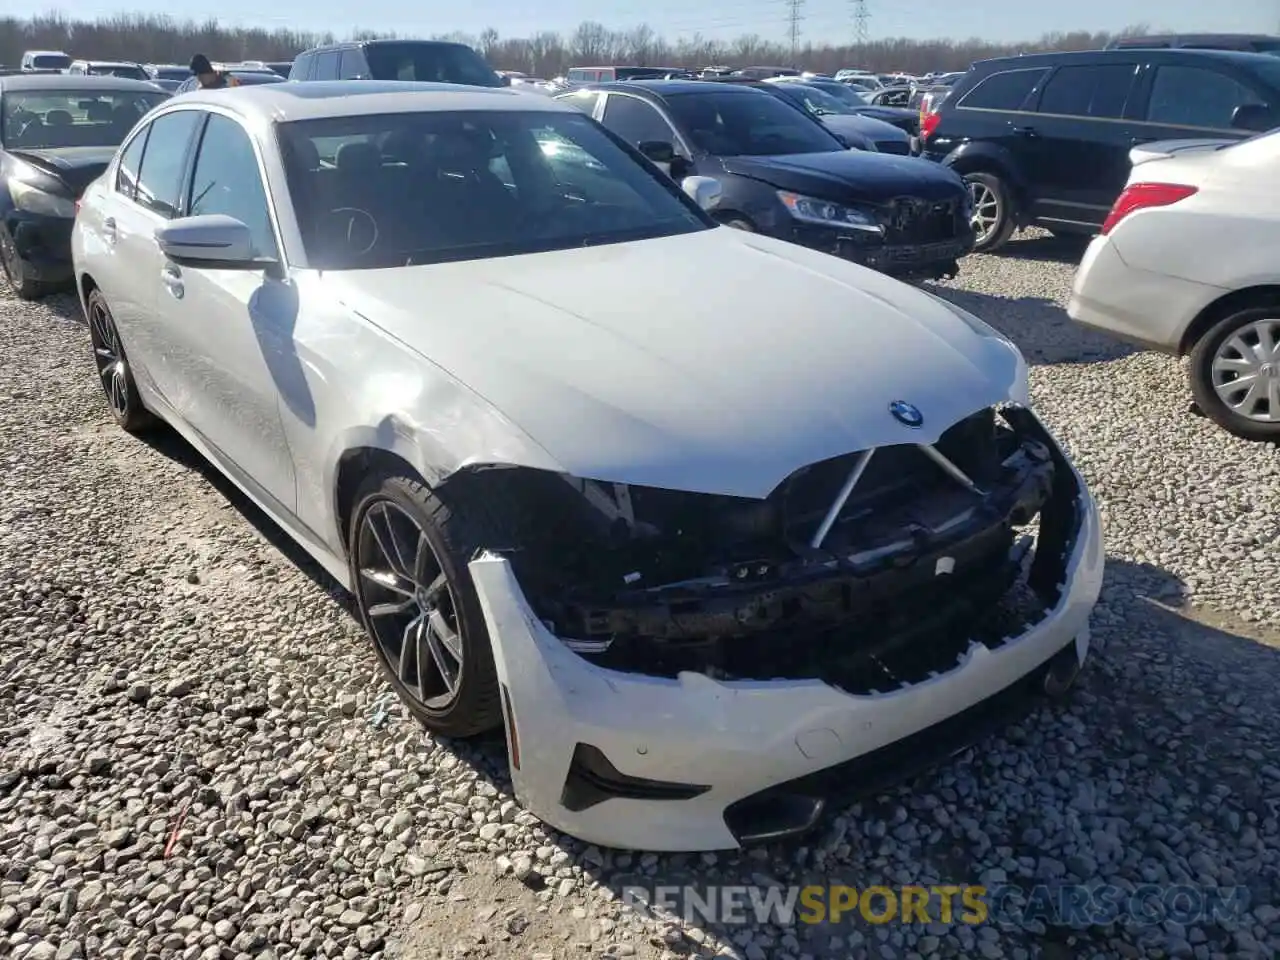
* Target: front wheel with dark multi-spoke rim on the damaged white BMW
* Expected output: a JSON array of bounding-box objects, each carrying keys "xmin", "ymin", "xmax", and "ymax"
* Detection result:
[{"xmin": 348, "ymin": 474, "xmax": 502, "ymax": 737}]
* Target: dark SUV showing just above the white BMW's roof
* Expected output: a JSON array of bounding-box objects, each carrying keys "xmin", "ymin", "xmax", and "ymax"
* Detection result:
[{"xmin": 289, "ymin": 40, "xmax": 511, "ymax": 87}]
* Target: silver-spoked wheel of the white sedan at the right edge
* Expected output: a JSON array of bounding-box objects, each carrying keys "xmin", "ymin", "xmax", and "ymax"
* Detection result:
[{"xmin": 1190, "ymin": 303, "xmax": 1280, "ymax": 442}]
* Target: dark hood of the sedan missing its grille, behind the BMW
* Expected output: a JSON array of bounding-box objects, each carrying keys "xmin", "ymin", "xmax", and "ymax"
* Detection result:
[{"xmin": 721, "ymin": 150, "xmax": 966, "ymax": 204}]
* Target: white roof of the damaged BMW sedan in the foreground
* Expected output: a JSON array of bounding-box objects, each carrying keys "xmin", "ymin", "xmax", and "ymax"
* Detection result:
[{"xmin": 167, "ymin": 81, "xmax": 580, "ymax": 123}]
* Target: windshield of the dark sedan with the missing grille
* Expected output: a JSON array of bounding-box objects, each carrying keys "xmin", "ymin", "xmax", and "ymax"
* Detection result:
[{"xmin": 667, "ymin": 90, "xmax": 846, "ymax": 156}]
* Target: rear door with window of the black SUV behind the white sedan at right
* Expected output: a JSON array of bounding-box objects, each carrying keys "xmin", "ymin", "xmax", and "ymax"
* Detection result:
[{"xmin": 1016, "ymin": 55, "xmax": 1140, "ymax": 227}]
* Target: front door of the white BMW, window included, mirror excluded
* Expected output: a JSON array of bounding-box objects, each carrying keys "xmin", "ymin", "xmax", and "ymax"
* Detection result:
[{"xmin": 157, "ymin": 113, "xmax": 297, "ymax": 512}]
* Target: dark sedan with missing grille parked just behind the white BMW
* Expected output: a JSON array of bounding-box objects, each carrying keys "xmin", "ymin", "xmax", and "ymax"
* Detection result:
[{"xmin": 559, "ymin": 81, "xmax": 973, "ymax": 276}]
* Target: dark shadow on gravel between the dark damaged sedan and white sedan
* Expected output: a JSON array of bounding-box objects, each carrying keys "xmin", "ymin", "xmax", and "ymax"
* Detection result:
[{"xmin": 927, "ymin": 285, "xmax": 1138, "ymax": 366}]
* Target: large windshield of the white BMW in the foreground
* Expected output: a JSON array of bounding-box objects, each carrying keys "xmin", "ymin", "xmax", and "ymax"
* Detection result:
[{"xmin": 278, "ymin": 110, "xmax": 714, "ymax": 270}]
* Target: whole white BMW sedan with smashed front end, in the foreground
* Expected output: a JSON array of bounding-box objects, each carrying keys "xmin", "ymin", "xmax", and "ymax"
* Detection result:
[{"xmin": 73, "ymin": 81, "xmax": 1103, "ymax": 850}]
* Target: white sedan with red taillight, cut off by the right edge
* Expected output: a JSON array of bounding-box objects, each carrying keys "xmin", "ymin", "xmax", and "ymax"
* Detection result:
[{"xmin": 1068, "ymin": 132, "xmax": 1280, "ymax": 440}]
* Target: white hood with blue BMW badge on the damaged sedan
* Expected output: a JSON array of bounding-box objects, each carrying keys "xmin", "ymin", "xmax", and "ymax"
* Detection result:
[{"xmin": 316, "ymin": 228, "xmax": 1025, "ymax": 497}]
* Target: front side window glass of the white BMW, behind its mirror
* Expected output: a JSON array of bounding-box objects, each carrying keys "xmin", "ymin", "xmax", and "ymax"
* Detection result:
[{"xmin": 187, "ymin": 114, "xmax": 278, "ymax": 260}]
